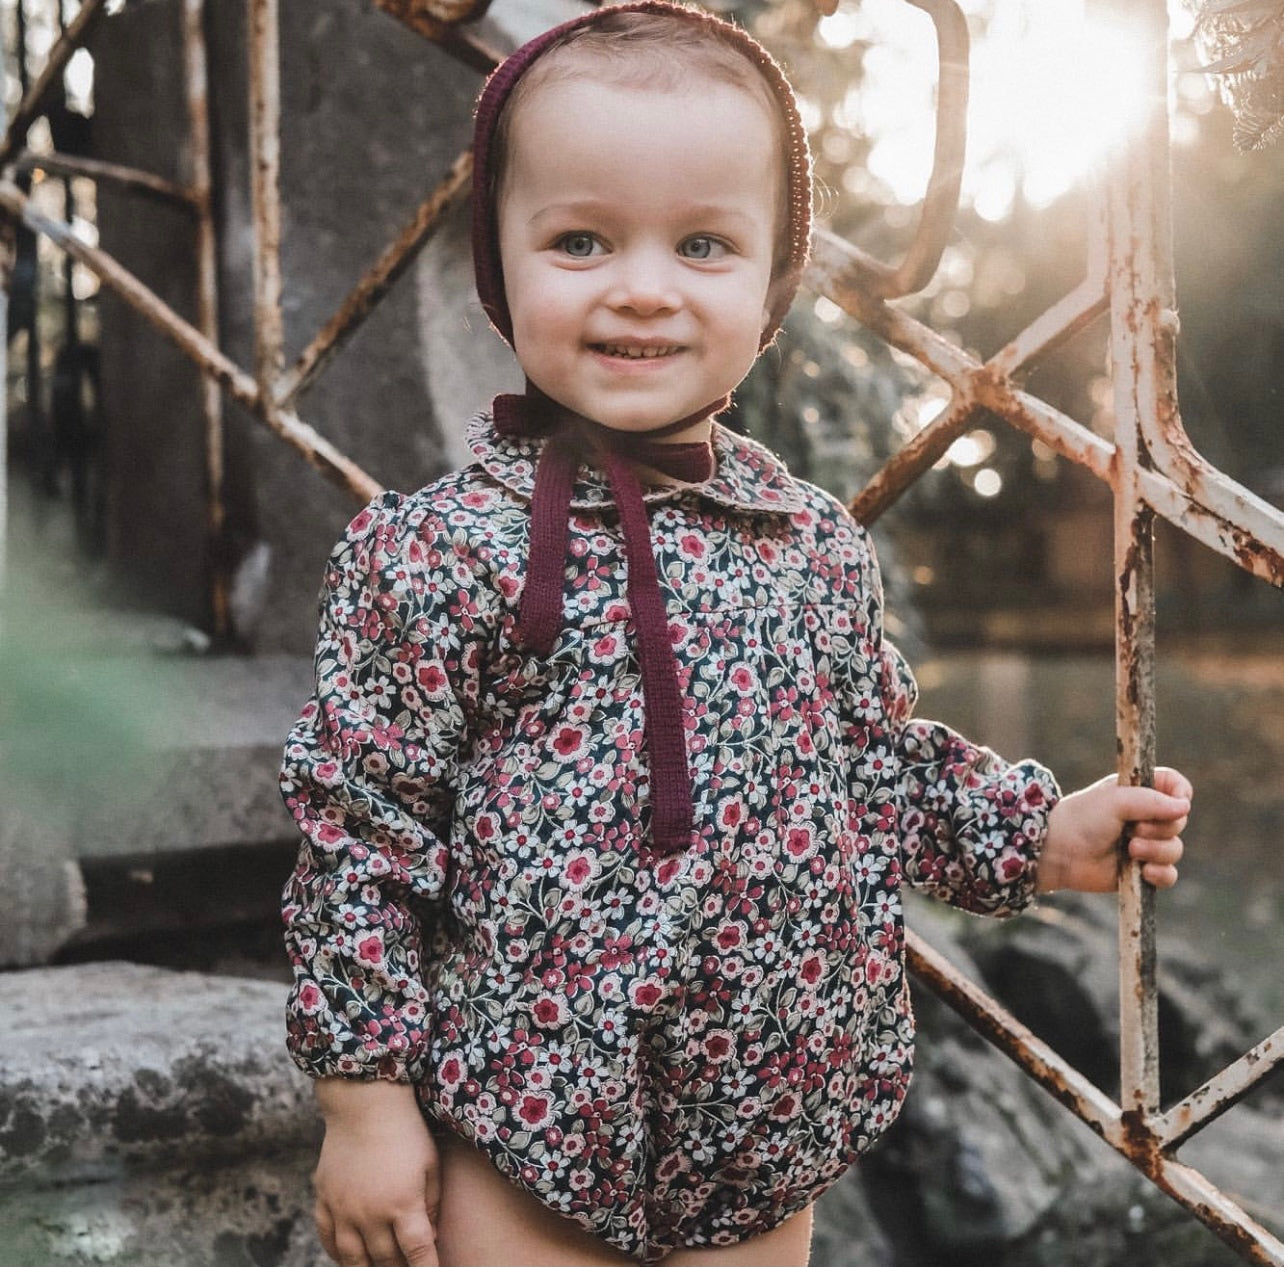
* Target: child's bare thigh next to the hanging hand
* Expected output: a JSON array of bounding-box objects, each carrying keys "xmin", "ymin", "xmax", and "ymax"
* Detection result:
[{"xmin": 437, "ymin": 1131, "xmax": 634, "ymax": 1267}]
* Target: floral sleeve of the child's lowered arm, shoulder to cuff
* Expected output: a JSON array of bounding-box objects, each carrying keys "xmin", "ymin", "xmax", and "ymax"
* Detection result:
[{"xmin": 280, "ymin": 494, "xmax": 484, "ymax": 1081}]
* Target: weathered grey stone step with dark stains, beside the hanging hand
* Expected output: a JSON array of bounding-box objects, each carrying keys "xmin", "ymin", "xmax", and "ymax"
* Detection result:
[{"xmin": 0, "ymin": 963, "xmax": 326, "ymax": 1267}]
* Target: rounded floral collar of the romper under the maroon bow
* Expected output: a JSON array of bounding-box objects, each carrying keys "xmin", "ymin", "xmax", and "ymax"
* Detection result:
[{"xmin": 466, "ymin": 411, "xmax": 804, "ymax": 515}]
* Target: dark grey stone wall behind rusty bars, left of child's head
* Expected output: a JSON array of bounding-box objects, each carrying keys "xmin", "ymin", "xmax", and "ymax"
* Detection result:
[{"xmin": 92, "ymin": 0, "xmax": 573, "ymax": 652}]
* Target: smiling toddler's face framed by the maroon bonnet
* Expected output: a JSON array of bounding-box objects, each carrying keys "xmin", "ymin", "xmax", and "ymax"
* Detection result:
[{"xmin": 498, "ymin": 78, "xmax": 783, "ymax": 441}]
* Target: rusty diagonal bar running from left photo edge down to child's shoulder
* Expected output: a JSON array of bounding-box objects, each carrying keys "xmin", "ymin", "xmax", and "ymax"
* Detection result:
[{"xmin": 0, "ymin": 181, "xmax": 383, "ymax": 502}]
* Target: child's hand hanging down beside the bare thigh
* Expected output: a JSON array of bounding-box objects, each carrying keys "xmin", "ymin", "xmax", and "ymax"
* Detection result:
[{"xmin": 313, "ymin": 1078, "xmax": 440, "ymax": 1267}]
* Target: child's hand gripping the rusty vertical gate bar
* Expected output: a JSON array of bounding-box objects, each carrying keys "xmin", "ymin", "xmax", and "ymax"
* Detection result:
[{"xmin": 1039, "ymin": 768, "xmax": 1193, "ymax": 893}]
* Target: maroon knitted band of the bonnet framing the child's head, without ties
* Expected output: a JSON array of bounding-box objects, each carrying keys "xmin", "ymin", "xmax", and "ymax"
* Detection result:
[{"xmin": 473, "ymin": 0, "xmax": 811, "ymax": 348}]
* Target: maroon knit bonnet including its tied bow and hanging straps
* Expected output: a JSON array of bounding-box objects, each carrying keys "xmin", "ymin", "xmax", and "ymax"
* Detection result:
[{"xmin": 473, "ymin": 0, "xmax": 811, "ymax": 852}]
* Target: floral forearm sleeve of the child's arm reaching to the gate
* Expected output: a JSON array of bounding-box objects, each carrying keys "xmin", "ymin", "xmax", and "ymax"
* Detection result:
[{"xmin": 881, "ymin": 643, "xmax": 1061, "ymax": 915}]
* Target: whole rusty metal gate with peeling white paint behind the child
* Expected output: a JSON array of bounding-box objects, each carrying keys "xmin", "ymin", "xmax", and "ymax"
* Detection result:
[{"xmin": 0, "ymin": 0, "xmax": 1284, "ymax": 1267}]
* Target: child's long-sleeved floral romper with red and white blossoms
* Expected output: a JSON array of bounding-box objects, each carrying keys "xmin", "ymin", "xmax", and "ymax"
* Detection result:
[{"xmin": 281, "ymin": 416, "xmax": 1058, "ymax": 1262}]
